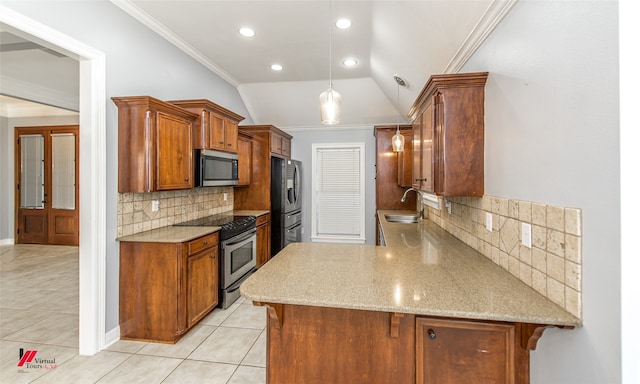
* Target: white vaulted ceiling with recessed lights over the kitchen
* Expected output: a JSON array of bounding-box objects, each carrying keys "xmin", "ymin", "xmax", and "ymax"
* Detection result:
[{"xmin": 3, "ymin": 0, "xmax": 516, "ymax": 129}]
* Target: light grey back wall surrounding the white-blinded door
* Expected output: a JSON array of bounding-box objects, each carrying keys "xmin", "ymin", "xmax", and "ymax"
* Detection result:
[{"xmin": 287, "ymin": 127, "xmax": 376, "ymax": 245}]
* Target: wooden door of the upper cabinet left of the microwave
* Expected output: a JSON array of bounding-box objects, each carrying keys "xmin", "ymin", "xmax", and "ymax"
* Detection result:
[{"xmin": 155, "ymin": 112, "xmax": 193, "ymax": 191}]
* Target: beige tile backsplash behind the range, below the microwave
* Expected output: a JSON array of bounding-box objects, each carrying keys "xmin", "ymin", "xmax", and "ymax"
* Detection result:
[{"xmin": 118, "ymin": 187, "xmax": 233, "ymax": 237}]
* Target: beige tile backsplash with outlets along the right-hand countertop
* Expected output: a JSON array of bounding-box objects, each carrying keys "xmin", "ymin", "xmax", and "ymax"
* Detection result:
[{"xmin": 424, "ymin": 196, "xmax": 582, "ymax": 318}]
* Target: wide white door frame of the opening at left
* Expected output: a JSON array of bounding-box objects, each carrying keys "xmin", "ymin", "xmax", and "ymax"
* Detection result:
[{"xmin": 0, "ymin": 5, "xmax": 106, "ymax": 355}]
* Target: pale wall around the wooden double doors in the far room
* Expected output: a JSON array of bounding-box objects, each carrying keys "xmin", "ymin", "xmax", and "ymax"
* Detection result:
[{"xmin": 0, "ymin": 112, "xmax": 78, "ymax": 244}]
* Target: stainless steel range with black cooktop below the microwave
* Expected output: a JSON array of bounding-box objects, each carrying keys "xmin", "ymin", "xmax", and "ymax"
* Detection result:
[{"xmin": 176, "ymin": 213, "xmax": 256, "ymax": 309}]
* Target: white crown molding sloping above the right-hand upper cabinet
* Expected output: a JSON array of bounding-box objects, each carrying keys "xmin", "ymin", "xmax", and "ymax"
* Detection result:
[{"xmin": 442, "ymin": 0, "xmax": 518, "ymax": 73}]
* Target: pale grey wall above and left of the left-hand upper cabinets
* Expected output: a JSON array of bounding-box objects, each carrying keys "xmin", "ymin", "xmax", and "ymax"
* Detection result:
[{"xmin": 2, "ymin": 0, "xmax": 252, "ymax": 332}]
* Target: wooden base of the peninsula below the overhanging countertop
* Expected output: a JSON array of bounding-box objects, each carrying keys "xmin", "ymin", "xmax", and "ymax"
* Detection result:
[{"xmin": 255, "ymin": 302, "xmax": 549, "ymax": 384}]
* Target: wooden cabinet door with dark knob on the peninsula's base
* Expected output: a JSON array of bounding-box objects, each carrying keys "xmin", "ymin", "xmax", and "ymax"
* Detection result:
[{"xmin": 416, "ymin": 318, "xmax": 515, "ymax": 384}]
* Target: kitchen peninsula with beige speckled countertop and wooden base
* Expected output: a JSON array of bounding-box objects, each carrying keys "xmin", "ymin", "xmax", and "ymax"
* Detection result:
[{"xmin": 240, "ymin": 215, "xmax": 581, "ymax": 383}]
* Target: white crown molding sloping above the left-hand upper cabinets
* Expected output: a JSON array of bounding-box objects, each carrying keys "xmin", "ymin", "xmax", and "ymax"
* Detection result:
[{"xmin": 110, "ymin": 0, "xmax": 240, "ymax": 88}]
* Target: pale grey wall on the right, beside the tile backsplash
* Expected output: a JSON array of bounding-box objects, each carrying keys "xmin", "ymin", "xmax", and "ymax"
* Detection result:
[{"xmin": 463, "ymin": 0, "xmax": 621, "ymax": 384}]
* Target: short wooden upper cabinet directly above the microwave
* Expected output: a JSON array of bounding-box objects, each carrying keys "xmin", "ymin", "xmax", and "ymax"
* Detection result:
[{"xmin": 169, "ymin": 99, "xmax": 244, "ymax": 153}]
